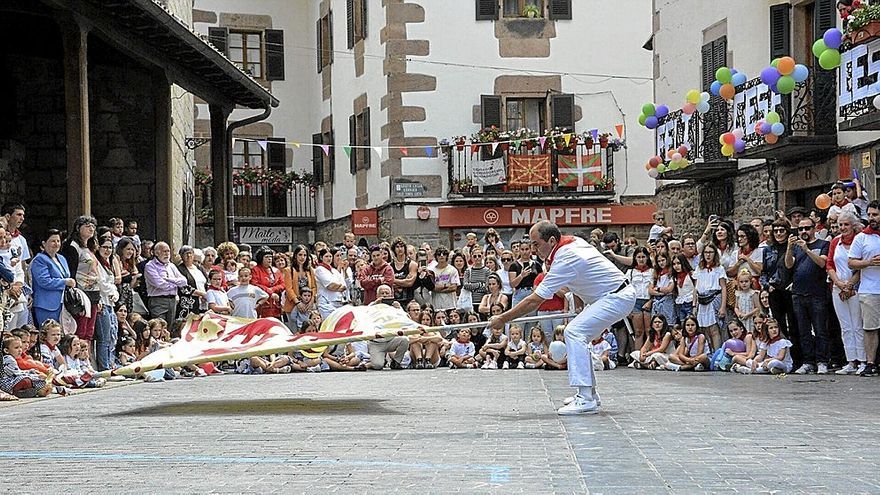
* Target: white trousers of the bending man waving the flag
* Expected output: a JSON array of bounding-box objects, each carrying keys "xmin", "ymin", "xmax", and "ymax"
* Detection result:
[{"xmin": 565, "ymin": 285, "xmax": 636, "ymax": 387}]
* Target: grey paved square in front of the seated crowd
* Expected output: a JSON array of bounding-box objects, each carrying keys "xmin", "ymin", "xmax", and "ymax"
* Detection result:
[{"xmin": 0, "ymin": 369, "xmax": 880, "ymax": 494}]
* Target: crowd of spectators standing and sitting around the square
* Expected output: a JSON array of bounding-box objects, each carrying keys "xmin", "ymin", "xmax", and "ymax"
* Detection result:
[{"xmin": 0, "ymin": 178, "xmax": 880, "ymax": 399}]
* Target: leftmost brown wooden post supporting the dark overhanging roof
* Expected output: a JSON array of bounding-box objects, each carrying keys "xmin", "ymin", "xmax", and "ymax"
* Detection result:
[{"xmin": 61, "ymin": 21, "xmax": 92, "ymax": 225}]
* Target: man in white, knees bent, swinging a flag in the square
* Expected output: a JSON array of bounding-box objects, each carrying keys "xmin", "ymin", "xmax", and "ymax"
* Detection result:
[{"xmin": 489, "ymin": 220, "xmax": 636, "ymax": 416}]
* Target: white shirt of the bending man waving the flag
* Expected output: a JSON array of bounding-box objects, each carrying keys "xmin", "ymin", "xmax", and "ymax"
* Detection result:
[{"xmin": 535, "ymin": 237, "xmax": 626, "ymax": 304}]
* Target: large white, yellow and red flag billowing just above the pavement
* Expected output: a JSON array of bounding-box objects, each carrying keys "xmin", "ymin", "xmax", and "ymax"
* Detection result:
[{"xmin": 96, "ymin": 304, "xmax": 422, "ymax": 377}]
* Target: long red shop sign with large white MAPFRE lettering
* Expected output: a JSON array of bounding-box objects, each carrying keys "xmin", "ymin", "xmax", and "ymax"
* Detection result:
[{"xmin": 439, "ymin": 205, "xmax": 657, "ymax": 227}]
